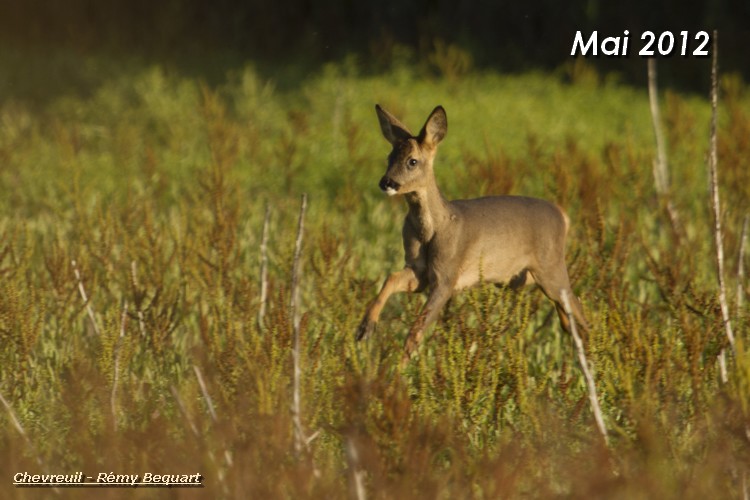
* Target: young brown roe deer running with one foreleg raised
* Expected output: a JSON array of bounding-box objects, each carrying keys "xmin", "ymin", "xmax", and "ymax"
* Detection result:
[{"xmin": 357, "ymin": 105, "xmax": 587, "ymax": 365}]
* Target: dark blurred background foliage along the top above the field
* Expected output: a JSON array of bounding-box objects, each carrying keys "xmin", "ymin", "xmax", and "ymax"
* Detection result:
[{"xmin": 0, "ymin": 0, "xmax": 750, "ymax": 90}]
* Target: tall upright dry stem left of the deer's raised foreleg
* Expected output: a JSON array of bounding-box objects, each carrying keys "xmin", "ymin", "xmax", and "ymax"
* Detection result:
[{"xmin": 289, "ymin": 193, "xmax": 307, "ymax": 454}]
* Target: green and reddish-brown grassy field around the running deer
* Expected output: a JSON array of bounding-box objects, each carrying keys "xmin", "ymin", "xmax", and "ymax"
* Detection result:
[{"xmin": 0, "ymin": 50, "xmax": 750, "ymax": 499}]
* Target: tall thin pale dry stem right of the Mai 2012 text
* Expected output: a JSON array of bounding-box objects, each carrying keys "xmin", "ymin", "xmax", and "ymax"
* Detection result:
[{"xmin": 708, "ymin": 30, "xmax": 736, "ymax": 364}]
